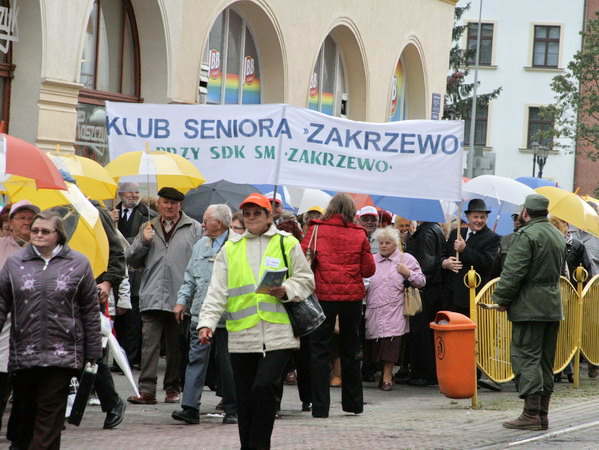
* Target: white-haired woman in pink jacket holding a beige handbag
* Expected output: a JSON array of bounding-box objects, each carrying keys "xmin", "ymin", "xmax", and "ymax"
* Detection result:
[{"xmin": 364, "ymin": 227, "xmax": 426, "ymax": 391}]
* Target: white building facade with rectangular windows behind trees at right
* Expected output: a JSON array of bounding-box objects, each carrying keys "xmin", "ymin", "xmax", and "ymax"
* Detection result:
[{"xmin": 457, "ymin": 0, "xmax": 585, "ymax": 189}]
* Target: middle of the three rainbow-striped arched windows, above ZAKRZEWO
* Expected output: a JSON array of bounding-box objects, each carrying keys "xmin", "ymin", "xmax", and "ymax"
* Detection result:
[{"xmin": 308, "ymin": 36, "xmax": 349, "ymax": 117}]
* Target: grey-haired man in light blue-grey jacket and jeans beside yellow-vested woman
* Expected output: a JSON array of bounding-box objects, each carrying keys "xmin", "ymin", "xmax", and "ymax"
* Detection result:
[{"xmin": 171, "ymin": 204, "xmax": 237, "ymax": 424}]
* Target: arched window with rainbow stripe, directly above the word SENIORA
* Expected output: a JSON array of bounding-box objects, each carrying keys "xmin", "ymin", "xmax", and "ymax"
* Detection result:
[{"xmin": 199, "ymin": 8, "xmax": 261, "ymax": 105}]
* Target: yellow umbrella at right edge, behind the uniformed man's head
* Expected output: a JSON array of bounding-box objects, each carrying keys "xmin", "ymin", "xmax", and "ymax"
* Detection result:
[{"xmin": 535, "ymin": 186, "xmax": 599, "ymax": 236}]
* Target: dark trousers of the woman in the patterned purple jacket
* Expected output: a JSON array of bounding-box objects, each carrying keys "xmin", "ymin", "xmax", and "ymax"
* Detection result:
[{"xmin": 12, "ymin": 367, "xmax": 77, "ymax": 449}]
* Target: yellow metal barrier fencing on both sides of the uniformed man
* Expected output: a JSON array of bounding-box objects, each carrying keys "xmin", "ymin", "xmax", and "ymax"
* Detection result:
[{"xmin": 469, "ymin": 275, "xmax": 599, "ymax": 387}]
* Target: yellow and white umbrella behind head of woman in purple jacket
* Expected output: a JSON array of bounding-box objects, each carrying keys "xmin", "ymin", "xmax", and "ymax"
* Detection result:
[{"xmin": 6, "ymin": 183, "xmax": 108, "ymax": 277}]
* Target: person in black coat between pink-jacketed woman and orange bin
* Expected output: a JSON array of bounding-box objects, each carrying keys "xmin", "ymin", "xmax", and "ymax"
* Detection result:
[{"xmin": 402, "ymin": 222, "xmax": 445, "ymax": 386}]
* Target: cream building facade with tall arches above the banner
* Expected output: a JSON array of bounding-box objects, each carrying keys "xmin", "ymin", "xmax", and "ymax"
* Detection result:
[{"xmin": 0, "ymin": 0, "xmax": 455, "ymax": 169}]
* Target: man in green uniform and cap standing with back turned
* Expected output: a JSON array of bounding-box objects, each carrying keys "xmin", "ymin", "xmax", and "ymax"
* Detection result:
[{"xmin": 493, "ymin": 194, "xmax": 566, "ymax": 430}]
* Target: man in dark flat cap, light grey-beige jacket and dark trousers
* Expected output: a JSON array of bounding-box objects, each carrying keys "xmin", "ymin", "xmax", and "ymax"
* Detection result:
[{"xmin": 126, "ymin": 187, "xmax": 203, "ymax": 405}]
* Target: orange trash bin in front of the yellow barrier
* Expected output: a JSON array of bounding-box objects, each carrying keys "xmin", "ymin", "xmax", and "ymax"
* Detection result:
[{"xmin": 430, "ymin": 311, "xmax": 476, "ymax": 398}]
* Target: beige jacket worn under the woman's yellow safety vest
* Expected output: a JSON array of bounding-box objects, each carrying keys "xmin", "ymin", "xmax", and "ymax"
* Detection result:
[{"xmin": 198, "ymin": 225, "xmax": 314, "ymax": 353}]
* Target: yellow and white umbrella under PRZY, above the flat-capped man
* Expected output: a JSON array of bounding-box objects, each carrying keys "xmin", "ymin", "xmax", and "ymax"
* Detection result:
[{"xmin": 106, "ymin": 150, "xmax": 206, "ymax": 193}]
